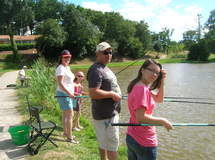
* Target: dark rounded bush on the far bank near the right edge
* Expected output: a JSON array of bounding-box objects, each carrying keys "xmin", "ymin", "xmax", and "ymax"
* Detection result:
[{"xmin": 188, "ymin": 39, "xmax": 210, "ymax": 61}]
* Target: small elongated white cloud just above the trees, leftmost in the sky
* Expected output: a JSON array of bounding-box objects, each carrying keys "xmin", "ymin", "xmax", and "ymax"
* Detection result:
[{"xmin": 82, "ymin": 2, "xmax": 113, "ymax": 12}]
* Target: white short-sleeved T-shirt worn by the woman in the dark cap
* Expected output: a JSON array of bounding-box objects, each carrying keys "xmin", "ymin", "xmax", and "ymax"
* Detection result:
[{"xmin": 55, "ymin": 64, "xmax": 75, "ymax": 94}]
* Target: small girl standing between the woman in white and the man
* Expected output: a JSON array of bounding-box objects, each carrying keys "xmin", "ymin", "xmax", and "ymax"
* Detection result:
[{"xmin": 73, "ymin": 72, "xmax": 85, "ymax": 131}]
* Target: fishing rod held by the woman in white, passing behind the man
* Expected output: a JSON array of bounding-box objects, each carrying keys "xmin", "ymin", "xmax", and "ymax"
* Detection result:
[{"xmin": 55, "ymin": 96, "xmax": 215, "ymax": 105}]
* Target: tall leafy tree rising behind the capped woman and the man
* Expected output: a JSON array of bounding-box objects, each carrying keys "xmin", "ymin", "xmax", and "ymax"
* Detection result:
[{"xmin": 62, "ymin": 5, "xmax": 101, "ymax": 57}]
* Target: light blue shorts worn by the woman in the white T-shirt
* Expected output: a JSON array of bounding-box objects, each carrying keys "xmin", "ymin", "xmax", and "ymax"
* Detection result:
[{"xmin": 56, "ymin": 91, "xmax": 76, "ymax": 110}]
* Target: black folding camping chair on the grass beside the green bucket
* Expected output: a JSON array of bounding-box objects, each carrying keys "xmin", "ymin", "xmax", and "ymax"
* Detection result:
[{"xmin": 27, "ymin": 106, "xmax": 58, "ymax": 155}]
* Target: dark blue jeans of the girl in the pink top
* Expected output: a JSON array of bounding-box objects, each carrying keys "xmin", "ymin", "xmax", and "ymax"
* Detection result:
[{"xmin": 126, "ymin": 134, "xmax": 157, "ymax": 160}]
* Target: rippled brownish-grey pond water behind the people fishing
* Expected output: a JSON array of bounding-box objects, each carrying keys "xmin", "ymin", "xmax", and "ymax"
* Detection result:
[{"xmin": 76, "ymin": 63, "xmax": 215, "ymax": 160}]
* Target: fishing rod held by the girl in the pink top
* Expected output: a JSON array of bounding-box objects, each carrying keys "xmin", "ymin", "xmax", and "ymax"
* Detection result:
[{"xmin": 111, "ymin": 123, "xmax": 215, "ymax": 127}]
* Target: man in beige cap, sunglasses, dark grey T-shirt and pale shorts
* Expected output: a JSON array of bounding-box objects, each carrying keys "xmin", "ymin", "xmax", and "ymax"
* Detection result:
[{"xmin": 87, "ymin": 42, "xmax": 121, "ymax": 160}]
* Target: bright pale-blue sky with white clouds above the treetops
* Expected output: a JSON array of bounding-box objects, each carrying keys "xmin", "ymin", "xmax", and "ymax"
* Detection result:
[{"xmin": 67, "ymin": 0, "xmax": 215, "ymax": 41}]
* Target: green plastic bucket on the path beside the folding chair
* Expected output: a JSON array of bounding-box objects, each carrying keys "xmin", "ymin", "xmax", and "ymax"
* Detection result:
[{"xmin": 8, "ymin": 125, "xmax": 31, "ymax": 145}]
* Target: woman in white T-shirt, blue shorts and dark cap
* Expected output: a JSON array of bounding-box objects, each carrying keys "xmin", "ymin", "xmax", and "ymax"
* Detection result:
[{"xmin": 56, "ymin": 50, "xmax": 79, "ymax": 144}]
